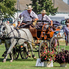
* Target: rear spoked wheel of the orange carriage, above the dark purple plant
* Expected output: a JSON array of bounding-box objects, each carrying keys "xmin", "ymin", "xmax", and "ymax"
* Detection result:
[{"xmin": 50, "ymin": 37, "xmax": 59, "ymax": 53}]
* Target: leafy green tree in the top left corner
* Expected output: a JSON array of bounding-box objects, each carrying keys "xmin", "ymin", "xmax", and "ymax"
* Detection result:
[{"xmin": 0, "ymin": 0, "xmax": 16, "ymax": 18}]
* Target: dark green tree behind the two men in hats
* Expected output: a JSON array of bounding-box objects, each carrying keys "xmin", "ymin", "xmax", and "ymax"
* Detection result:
[{"xmin": 30, "ymin": 0, "xmax": 58, "ymax": 15}]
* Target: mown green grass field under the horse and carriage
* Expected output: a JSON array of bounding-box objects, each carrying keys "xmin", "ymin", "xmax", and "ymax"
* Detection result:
[{"xmin": 0, "ymin": 41, "xmax": 69, "ymax": 69}]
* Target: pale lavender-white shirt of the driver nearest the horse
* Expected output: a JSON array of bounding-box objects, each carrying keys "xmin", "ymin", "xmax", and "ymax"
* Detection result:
[{"xmin": 20, "ymin": 10, "xmax": 38, "ymax": 21}]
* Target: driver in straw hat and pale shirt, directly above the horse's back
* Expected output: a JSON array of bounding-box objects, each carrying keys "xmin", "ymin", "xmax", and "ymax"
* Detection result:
[{"xmin": 19, "ymin": 5, "xmax": 38, "ymax": 26}]
